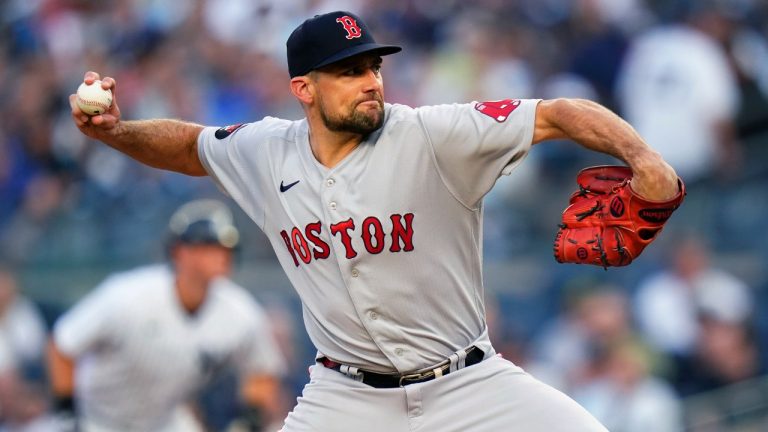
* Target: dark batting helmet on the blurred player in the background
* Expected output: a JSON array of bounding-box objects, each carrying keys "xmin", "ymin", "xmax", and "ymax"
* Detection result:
[{"xmin": 168, "ymin": 199, "xmax": 240, "ymax": 249}]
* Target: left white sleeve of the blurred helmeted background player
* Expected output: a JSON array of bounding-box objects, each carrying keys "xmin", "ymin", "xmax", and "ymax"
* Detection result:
[{"xmin": 53, "ymin": 278, "xmax": 121, "ymax": 358}]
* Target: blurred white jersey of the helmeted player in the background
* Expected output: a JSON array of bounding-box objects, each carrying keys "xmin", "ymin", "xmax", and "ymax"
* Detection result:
[{"xmin": 54, "ymin": 266, "xmax": 284, "ymax": 431}]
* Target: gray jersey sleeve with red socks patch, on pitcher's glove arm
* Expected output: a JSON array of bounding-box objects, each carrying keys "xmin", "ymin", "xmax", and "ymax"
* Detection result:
[{"xmin": 418, "ymin": 99, "xmax": 539, "ymax": 208}]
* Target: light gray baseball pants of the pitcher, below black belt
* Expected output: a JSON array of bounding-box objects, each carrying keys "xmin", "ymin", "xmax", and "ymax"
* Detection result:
[{"xmin": 282, "ymin": 356, "xmax": 607, "ymax": 432}]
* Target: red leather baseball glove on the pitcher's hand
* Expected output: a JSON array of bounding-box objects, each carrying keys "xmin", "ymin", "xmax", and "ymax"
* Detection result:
[{"xmin": 554, "ymin": 165, "xmax": 685, "ymax": 269}]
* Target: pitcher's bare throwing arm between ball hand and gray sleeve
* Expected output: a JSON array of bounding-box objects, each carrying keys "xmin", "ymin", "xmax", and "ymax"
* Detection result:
[{"xmin": 95, "ymin": 119, "xmax": 207, "ymax": 176}]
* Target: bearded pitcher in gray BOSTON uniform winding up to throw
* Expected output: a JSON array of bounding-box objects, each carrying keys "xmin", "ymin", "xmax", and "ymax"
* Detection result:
[{"xmin": 71, "ymin": 11, "xmax": 683, "ymax": 432}]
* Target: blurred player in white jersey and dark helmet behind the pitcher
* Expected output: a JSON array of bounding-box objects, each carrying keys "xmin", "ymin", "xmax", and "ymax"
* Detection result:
[{"xmin": 49, "ymin": 200, "xmax": 284, "ymax": 432}]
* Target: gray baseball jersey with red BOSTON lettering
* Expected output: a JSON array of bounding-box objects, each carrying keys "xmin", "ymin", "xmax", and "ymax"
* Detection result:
[{"xmin": 198, "ymin": 100, "xmax": 538, "ymax": 373}]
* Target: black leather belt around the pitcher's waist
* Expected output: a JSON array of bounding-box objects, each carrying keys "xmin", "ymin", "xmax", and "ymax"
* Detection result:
[{"xmin": 317, "ymin": 346, "xmax": 485, "ymax": 388}]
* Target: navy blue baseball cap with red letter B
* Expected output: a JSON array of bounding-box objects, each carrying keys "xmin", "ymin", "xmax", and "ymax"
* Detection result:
[{"xmin": 286, "ymin": 11, "xmax": 402, "ymax": 78}]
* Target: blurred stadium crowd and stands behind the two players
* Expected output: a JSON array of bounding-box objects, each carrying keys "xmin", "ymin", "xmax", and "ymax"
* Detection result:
[{"xmin": 0, "ymin": 0, "xmax": 768, "ymax": 432}]
